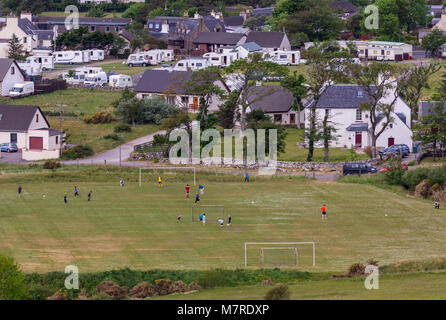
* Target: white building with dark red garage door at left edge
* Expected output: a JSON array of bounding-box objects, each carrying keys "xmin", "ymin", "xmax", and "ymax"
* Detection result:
[{"xmin": 0, "ymin": 105, "xmax": 63, "ymax": 161}]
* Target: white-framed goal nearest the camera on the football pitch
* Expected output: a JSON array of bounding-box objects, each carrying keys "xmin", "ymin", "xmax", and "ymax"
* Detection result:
[{"xmin": 245, "ymin": 242, "xmax": 316, "ymax": 267}]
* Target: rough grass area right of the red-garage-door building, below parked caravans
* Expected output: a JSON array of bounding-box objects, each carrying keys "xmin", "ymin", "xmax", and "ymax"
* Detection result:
[{"xmin": 3, "ymin": 88, "xmax": 158, "ymax": 153}]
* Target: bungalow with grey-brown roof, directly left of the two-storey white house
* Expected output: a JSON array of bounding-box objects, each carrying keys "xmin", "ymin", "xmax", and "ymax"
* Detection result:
[{"xmin": 246, "ymin": 86, "xmax": 304, "ymax": 126}]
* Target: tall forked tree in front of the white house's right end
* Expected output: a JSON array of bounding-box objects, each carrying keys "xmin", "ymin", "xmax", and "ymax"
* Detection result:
[{"xmin": 354, "ymin": 62, "xmax": 407, "ymax": 158}]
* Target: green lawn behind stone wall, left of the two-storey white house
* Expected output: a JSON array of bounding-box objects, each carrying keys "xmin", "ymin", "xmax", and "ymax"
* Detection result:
[{"xmin": 278, "ymin": 128, "xmax": 369, "ymax": 162}]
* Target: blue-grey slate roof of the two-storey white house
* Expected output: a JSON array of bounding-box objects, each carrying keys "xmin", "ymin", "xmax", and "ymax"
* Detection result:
[{"xmin": 306, "ymin": 85, "xmax": 370, "ymax": 109}]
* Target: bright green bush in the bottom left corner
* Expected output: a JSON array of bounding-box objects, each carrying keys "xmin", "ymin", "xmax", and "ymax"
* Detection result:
[{"xmin": 0, "ymin": 255, "xmax": 28, "ymax": 300}]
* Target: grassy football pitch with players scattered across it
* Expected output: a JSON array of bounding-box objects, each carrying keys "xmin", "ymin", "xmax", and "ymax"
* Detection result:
[{"xmin": 0, "ymin": 172, "xmax": 446, "ymax": 272}]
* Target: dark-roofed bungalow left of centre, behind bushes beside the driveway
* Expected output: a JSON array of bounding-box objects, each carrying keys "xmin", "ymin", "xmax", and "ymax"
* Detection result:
[{"xmin": 134, "ymin": 70, "xmax": 230, "ymax": 112}]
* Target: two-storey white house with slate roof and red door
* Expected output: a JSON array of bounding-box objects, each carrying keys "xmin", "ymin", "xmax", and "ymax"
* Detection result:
[{"xmin": 305, "ymin": 85, "xmax": 412, "ymax": 149}]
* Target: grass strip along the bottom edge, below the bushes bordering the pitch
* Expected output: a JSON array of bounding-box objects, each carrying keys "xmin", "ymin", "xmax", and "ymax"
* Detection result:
[{"xmin": 152, "ymin": 272, "xmax": 446, "ymax": 300}]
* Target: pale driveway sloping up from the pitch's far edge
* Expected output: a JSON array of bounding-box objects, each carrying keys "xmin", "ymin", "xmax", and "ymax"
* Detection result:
[{"xmin": 61, "ymin": 131, "xmax": 166, "ymax": 166}]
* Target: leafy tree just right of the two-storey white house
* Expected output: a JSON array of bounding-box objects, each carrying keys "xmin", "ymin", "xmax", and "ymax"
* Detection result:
[{"xmin": 399, "ymin": 63, "xmax": 441, "ymax": 124}]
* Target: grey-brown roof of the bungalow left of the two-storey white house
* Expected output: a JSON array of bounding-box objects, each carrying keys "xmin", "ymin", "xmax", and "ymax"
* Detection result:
[{"xmin": 248, "ymin": 86, "xmax": 294, "ymax": 113}]
